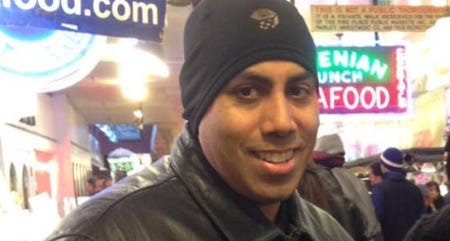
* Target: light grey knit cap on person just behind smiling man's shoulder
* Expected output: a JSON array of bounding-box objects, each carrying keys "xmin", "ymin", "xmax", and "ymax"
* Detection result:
[{"xmin": 312, "ymin": 134, "xmax": 345, "ymax": 168}]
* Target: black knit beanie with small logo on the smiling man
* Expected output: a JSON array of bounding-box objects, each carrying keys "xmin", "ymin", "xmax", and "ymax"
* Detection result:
[{"xmin": 180, "ymin": 0, "xmax": 317, "ymax": 138}]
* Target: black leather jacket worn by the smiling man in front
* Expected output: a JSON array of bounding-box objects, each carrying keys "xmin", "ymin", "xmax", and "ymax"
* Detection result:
[{"xmin": 46, "ymin": 130, "xmax": 352, "ymax": 241}]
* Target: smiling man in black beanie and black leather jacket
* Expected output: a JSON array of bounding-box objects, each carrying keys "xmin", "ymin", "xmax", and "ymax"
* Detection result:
[{"xmin": 47, "ymin": 0, "xmax": 352, "ymax": 241}]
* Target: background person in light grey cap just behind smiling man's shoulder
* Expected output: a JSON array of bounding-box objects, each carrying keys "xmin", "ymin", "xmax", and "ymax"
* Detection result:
[{"xmin": 298, "ymin": 134, "xmax": 381, "ymax": 241}]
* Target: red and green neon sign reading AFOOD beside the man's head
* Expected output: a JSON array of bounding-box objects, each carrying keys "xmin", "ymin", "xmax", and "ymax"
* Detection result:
[{"xmin": 317, "ymin": 46, "xmax": 409, "ymax": 114}]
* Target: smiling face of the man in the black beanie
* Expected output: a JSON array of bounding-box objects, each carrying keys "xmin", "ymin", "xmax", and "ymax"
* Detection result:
[{"xmin": 199, "ymin": 61, "xmax": 319, "ymax": 204}]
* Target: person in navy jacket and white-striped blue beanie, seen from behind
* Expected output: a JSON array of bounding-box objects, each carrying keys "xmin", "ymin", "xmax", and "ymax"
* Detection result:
[{"xmin": 372, "ymin": 147, "xmax": 425, "ymax": 241}]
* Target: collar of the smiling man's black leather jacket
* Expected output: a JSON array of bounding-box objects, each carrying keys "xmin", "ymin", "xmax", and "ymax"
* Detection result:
[{"xmin": 171, "ymin": 129, "xmax": 312, "ymax": 241}]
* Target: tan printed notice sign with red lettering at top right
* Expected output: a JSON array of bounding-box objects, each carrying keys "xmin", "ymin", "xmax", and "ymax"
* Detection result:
[{"xmin": 311, "ymin": 5, "xmax": 447, "ymax": 32}]
